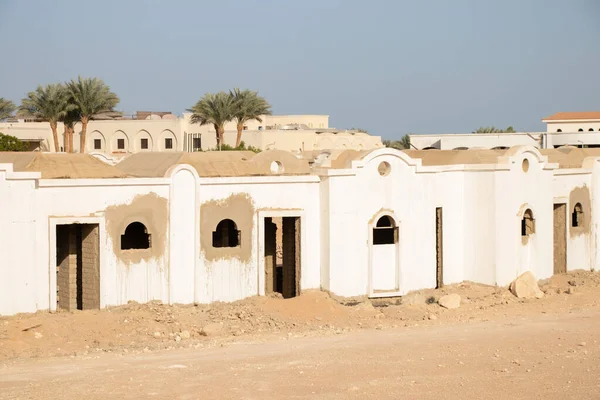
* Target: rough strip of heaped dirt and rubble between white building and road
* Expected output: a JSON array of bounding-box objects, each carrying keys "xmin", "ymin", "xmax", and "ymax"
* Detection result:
[{"xmin": 0, "ymin": 271, "xmax": 600, "ymax": 359}]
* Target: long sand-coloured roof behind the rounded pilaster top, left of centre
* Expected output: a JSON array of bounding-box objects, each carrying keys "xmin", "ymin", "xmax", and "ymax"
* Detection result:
[{"xmin": 116, "ymin": 150, "xmax": 310, "ymax": 177}]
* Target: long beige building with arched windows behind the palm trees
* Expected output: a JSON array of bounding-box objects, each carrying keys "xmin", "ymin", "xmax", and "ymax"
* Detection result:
[{"xmin": 0, "ymin": 112, "xmax": 383, "ymax": 159}]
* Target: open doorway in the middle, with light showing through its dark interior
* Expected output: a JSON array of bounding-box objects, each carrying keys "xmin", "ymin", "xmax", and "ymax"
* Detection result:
[{"xmin": 264, "ymin": 217, "xmax": 301, "ymax": 299}]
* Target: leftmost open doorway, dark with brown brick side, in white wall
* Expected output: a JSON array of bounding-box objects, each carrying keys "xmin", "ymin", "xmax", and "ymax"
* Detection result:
[{"xmin": 56, "ymin": 224, "xmax": 100, "ymax": 311}]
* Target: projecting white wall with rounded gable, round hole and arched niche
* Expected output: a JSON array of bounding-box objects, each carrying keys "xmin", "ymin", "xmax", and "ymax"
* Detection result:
[{"xmin": 323, "ymin": 149, "xmax": 462, "ymax": 296}]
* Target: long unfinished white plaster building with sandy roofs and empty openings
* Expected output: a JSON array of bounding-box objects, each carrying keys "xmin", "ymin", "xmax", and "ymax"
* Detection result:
[{"xmin": 0, "ymin": 146, "xmax": 600, "ymax": 315}]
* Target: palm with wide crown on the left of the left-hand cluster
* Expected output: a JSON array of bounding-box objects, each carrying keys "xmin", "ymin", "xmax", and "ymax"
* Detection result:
[{"xmin": 19, "ymin": 83, "xmax": 72, "ymax": 153}]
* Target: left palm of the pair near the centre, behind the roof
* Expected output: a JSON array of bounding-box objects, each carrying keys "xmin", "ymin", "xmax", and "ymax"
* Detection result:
[{"xmin": 187, "ymin": 92, "xmax": 235, "ymax": 146}]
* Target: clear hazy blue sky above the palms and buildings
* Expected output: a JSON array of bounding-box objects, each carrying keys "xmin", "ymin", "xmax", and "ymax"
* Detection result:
[{"xmin": 0, "ymin": 0, "xmax": 600, "ymax": 139}]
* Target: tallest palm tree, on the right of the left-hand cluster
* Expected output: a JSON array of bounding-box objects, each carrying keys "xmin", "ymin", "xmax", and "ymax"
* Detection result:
[{"xmin": 67, "ymin": 76, "xmax": 119, "ymax": 153}]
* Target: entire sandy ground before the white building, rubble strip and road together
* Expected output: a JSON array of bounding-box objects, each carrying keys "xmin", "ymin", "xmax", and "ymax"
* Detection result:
[{"xmin": 0, "ymin": 272, "xmax": 600, "ymax": 399}]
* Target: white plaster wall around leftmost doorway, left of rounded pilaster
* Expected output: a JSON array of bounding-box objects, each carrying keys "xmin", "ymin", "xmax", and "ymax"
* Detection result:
[{"xmin": 37, "ymin": 183, "xmax": 169, "ymax": 309}]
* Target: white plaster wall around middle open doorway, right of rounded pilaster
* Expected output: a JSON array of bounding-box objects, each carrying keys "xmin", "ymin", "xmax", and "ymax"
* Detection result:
[{"xmin": 195, "ymin": 177, "xmax": 321, "ymax": 303}]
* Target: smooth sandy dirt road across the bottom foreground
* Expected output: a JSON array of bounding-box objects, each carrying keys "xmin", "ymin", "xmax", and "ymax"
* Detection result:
[{"xmin": 0, "ymin": 310, "xmax": 600, "ymax": 400}]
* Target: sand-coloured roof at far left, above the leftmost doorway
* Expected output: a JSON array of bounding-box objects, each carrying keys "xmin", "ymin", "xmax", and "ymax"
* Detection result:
[{"xmin": 0, "ymin": 152, "xmax": 127, "ymax": 179}]
